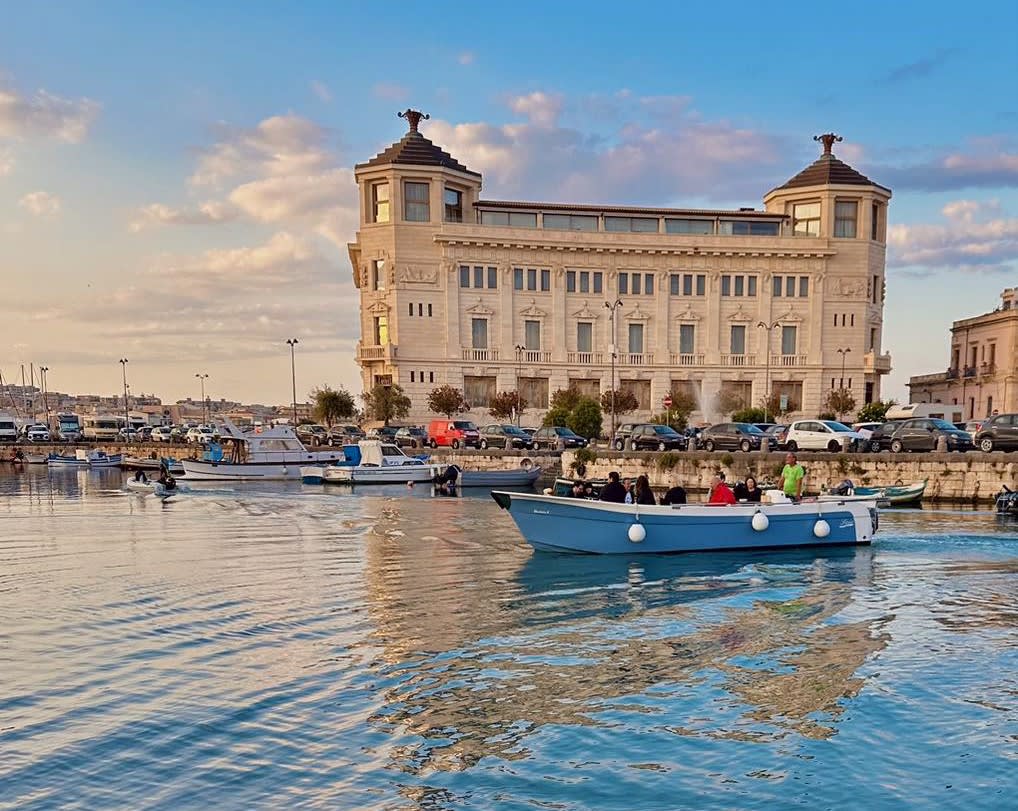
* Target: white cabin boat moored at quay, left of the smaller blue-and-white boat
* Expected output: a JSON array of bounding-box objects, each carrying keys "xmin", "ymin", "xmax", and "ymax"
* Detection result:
[{"xmin": 182, "ymin": 419, "xmax": 346, "ymax": 481}]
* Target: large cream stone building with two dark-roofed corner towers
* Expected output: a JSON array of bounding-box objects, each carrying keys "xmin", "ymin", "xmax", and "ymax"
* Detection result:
[{"xmin": 349, "ymin": 115, "xmax": 891, "ymax": 424}]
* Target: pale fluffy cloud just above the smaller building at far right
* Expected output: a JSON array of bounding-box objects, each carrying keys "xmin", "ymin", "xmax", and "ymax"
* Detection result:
[{"xmin": 888, "ymin": 199, "xmax": 1018, "ymax": 274}]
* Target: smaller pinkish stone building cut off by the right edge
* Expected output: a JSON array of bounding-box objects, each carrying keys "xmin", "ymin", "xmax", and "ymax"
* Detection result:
[{"xmin": 908, "ymin": 287, "xmax": 1018, "ymax": 421}]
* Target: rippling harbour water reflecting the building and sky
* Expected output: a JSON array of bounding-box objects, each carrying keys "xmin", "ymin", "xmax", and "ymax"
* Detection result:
[{"xmin": 0, "ymin": 468, "xmax": 1018, "ymax": 809}]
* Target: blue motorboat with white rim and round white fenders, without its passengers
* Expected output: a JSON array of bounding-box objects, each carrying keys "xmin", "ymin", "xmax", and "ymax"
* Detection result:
[{"xmin": 492, "ymin": 490, "xmax": 878, "ymax": 555}]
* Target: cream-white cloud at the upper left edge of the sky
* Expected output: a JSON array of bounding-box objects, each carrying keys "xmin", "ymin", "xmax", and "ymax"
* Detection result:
[{"xmin": 0, "ymin": 86, "xmax": 100, "ymax": 143}]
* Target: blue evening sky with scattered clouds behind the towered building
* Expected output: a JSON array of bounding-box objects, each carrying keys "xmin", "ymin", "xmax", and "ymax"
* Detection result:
[{"xmin": 0, "ymin": 2, "xmax": 1018, "ymax": 402}]
